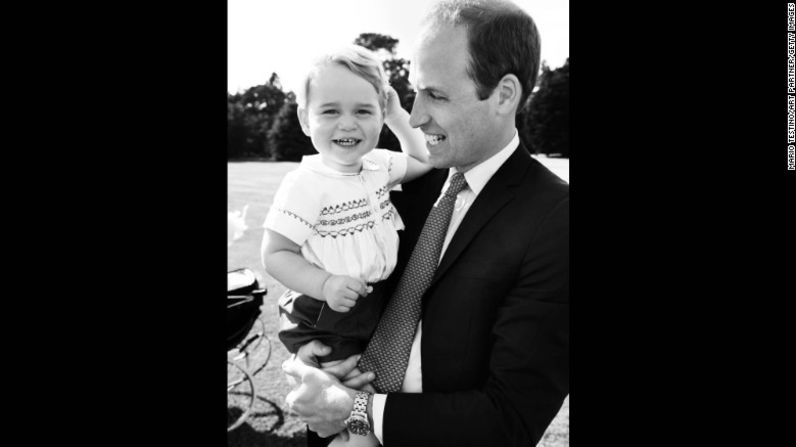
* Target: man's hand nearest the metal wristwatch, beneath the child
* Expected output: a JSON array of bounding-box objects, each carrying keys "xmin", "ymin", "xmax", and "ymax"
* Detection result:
[{"xmin": 282, "ymin": 358, "xmax": 356, "ymax": 437}]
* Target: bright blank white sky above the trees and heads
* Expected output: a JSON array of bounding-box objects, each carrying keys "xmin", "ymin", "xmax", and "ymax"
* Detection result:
[{"xmin": 227, "ymin": 0, "xmax": 569, "ymax": 93}]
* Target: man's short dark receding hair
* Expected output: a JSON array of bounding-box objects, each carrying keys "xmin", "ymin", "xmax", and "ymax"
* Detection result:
[{"xmin": 426, "ymin": 0, "xmax": 540, "ymax": 111}]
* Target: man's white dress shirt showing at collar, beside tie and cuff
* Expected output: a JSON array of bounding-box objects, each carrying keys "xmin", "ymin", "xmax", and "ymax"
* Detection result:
[{"xmin": 373, "ymin": 129, "xmax": 520, "ymax": 444}]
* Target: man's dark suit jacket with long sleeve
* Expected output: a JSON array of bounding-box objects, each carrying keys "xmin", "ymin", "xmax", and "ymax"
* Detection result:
[{"xmin": 383, "ymin": 145, "xmax": 569, "ymax": 447}]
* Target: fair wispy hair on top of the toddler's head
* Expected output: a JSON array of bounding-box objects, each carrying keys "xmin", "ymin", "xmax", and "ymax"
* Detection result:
[{"xmin": 296, "ymin": 44, "xmax": 387, "ymax": 112}]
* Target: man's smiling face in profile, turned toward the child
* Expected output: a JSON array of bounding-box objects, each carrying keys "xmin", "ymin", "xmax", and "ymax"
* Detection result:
[{"xmin": 409, "ymin": 25, "xmax": 500, "ymax": 171}]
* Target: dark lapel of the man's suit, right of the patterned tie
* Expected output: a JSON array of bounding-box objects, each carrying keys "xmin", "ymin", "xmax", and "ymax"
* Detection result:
[{"xmin": 431, "ymin": 144, "xmax": 530, "ymax": 286}]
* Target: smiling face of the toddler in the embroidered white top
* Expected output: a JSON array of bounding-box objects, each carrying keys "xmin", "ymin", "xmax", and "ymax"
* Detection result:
[{"xmin": 299, "ymin": 65, "xmax": 384, "ymax": 172}]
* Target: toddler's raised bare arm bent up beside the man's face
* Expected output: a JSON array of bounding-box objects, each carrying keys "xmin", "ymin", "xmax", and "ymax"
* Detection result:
[{"xmin": 384, "ymin": 86, "xmax": 431, "ymax": 182}]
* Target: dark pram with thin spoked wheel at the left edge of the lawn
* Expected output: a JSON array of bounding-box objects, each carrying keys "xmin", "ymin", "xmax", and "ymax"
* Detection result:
[{"xmin": 226, "ymin": 268, "xmax": 271, "ymax": 431}]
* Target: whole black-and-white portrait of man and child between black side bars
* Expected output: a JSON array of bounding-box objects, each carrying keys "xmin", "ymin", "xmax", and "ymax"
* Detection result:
[{"xmin": 226, "ymin": 0, "xmax": 571, "ymax": 447}]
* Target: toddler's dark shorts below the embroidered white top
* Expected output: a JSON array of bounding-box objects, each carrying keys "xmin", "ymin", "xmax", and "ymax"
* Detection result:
[{"xmin": 279, "ymin": 281, "xmax": 387, "ymax": 362}]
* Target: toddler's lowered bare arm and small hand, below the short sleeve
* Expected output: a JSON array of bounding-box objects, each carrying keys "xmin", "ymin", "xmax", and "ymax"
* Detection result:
[{"xmin": 262, "ymin": 229, "xmax": 369, "ymax": 312}]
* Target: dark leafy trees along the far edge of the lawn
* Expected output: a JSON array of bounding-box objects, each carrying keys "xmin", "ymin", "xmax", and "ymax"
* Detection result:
[{"xmin": 227, "ymin": 33, "xmax": 569, "ymax": 161}]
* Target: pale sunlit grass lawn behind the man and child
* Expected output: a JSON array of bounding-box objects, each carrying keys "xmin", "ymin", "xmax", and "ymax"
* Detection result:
[{"xmin": 227, "ymin": 158, "xmax": 569, "ymax": 447}]
